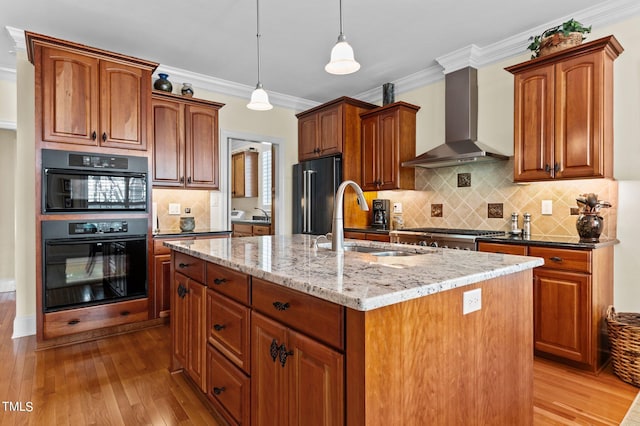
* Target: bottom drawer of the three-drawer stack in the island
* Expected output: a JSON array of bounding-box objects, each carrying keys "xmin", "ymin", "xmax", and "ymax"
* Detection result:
[{"xmin": 207, "ymin": 345, "xmax": 251, "ymax": 425}]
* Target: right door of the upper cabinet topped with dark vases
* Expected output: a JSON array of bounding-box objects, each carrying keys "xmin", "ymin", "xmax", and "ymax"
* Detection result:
[{"xmin": 185, "ymin": 105, "xmax": 220, "ymax": 189}]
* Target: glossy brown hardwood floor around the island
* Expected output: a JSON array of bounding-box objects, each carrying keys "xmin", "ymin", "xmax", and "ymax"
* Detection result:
[{"xmin": 0, "ymin": 293, "xmax": 638, "ymax": 426}]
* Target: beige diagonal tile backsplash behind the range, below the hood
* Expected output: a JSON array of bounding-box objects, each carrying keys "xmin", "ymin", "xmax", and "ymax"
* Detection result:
[{"xmin": 377, "ymin": 159, "xmax": 618, "ymax": 238}]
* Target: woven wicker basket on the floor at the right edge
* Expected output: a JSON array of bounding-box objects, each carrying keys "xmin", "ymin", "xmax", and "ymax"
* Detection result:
[{"xmin": 607, "ymin": 306, "xmax": 640, "ymax": 387}]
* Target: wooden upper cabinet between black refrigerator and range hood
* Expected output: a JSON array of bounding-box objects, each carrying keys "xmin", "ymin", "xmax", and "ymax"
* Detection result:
[{"xmin": 360, "ymin": 102, "xmax": 420, "ymax": 191}]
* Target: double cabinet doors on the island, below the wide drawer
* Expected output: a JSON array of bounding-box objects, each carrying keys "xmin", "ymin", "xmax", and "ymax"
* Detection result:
[{"xmin": 251, "ymin": 311, "xmax": 344, "ymax": 425}]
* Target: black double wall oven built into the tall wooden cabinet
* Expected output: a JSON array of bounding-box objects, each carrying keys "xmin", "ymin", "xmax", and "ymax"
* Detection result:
[{"xmin": 41, "ymin": 149, "xmax": 149, "ymax": 313}]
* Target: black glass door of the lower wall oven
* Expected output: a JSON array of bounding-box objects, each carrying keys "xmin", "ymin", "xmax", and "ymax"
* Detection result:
[{"xmin": 43, "ymin": 235, "xmax": 147, "ymax": 312}]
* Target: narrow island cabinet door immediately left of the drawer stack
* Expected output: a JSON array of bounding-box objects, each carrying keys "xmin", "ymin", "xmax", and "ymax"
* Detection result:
[{"xmin": 187, "ymin": 280, "xmax": 207, "ymax": 393}]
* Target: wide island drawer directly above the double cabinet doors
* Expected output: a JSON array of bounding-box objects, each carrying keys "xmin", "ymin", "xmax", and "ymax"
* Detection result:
[{"xmin": 251, "ymin": 278, "xmax": 344, "ymax": 349}]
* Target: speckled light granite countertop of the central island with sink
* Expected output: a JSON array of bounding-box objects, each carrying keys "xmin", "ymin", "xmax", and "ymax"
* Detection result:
[{"xmin": 164, "ymin": 235, "xmax": 544, "ymax": 311}]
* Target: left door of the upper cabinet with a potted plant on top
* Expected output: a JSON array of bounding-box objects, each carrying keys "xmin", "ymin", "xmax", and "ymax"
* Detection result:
[{"xmin": 514, "ymin": 65, "xmax": 557, "ymax": 181}]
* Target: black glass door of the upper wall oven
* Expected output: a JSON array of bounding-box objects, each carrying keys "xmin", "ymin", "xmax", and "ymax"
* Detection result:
[{"xmin": 42, "ymin": 168, "xmax": 148, "ymax": 213}]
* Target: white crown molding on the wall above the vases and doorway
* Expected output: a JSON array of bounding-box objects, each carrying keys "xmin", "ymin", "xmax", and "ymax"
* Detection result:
[{"xmin": 156, "ymin": 65, "xmax": 320, "ymax": 111}]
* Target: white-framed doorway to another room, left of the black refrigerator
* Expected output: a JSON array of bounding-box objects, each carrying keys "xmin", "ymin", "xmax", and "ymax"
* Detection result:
[{"xmin": 220, "ymin": 130, "xmax": 284, "ymax": 234}]
